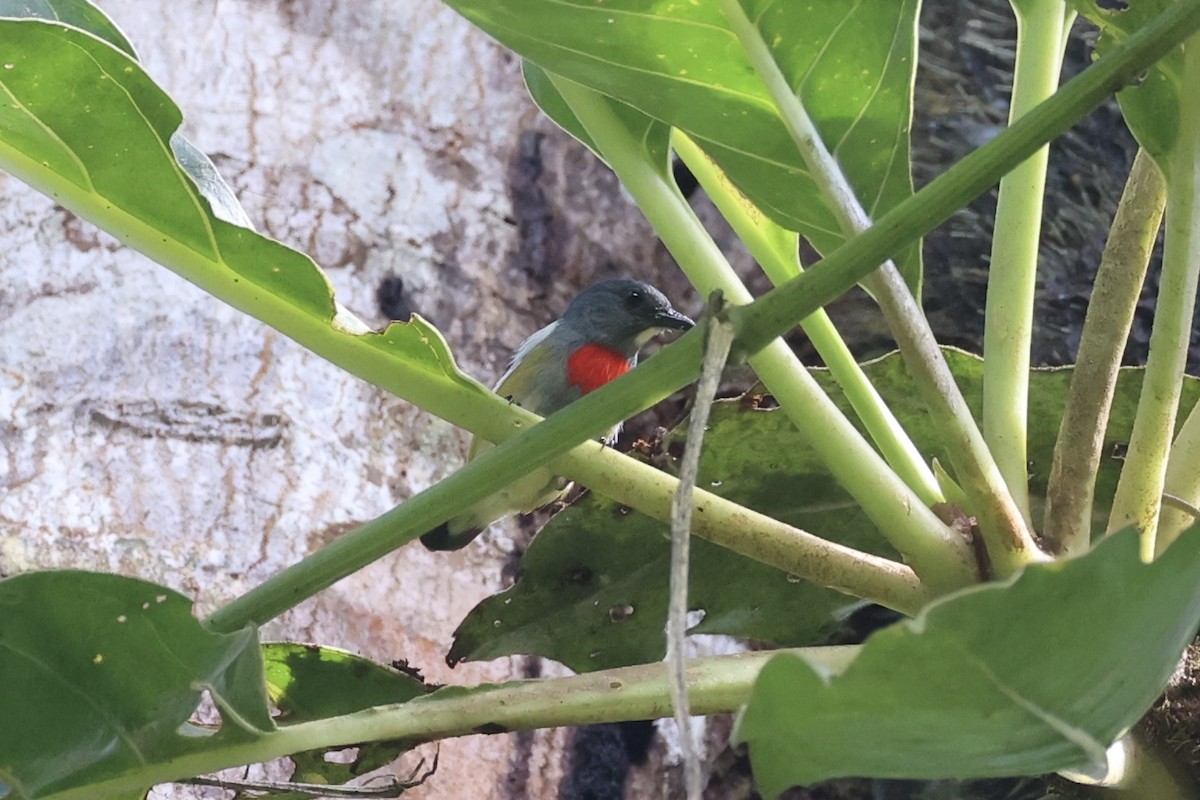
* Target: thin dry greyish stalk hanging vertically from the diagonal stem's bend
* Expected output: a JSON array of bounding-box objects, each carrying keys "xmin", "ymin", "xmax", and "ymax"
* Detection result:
[{"xmin": 667, "ymin": 311, "xmax": 733, "ymax": 800}]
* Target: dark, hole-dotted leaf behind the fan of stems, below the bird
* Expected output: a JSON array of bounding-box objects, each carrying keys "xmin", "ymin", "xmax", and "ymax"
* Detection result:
[{"xmin": 449, "ymin": 349, "xmax": 1200, "ymax": 672}]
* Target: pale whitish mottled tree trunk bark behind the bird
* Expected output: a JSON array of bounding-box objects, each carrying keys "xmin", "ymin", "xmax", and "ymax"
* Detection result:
[{"xmin": 0, "ymin": 0, "xmax": 710, "ymax": 799}]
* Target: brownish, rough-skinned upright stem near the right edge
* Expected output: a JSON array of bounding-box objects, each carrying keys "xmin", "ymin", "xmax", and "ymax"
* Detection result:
[{"xmin": 1042, "ymin": 150, "xmax": 1166, "ymax": 555}]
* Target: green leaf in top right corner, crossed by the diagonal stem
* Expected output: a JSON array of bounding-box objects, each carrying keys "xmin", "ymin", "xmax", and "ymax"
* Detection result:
[{"xmin": 1072, "ymin": 0, "xmax": 1183, "ymax": 169}]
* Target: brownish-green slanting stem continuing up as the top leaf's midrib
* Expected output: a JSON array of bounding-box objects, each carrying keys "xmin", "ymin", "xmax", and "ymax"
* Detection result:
[{"xmin": 721, "ymin": 0, "xmax": 1046, "ymax": 575}]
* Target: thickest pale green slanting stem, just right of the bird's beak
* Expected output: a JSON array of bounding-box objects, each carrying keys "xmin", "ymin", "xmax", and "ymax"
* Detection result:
[{"xmin": 551, "ymin": 74, "xmax": 978, "ymax": 590}]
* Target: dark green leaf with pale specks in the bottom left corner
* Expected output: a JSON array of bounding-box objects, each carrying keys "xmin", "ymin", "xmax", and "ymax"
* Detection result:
[{"xmin": 0, "ymin": 571, "xmax": 275, "ymax": 798}]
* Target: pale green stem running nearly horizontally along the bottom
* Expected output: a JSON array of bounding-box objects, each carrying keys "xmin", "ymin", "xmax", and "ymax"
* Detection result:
[{"xmin": 41, "ymin": 648, "xmax": 859, "ymax": 800}]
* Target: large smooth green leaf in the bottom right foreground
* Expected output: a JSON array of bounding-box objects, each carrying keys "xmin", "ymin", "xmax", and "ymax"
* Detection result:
[{"xmin": 737, "ymin": 530, "xmax": 1200, "ymax": 798}]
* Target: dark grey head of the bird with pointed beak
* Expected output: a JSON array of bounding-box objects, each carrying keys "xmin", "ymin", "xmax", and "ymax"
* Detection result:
[{"xmin": 562, "ymin": 278, "xmax": 694, "ymax": 356}]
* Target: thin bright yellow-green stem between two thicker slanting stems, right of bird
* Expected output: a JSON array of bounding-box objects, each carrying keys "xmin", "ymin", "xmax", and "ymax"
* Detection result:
[{"xmin": 671, "ymin": 130, "xmax": 946, "ymax": 506}]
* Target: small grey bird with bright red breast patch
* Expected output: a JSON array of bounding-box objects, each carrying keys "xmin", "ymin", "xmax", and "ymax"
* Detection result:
[{"xmin": 421, "ymin": 278, "xmax": 695, "ymax": 551}]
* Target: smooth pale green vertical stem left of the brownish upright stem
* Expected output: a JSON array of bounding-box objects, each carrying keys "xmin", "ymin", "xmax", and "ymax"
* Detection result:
[{"xmin": 983, "ymin": 0, "xmax": 1073, "ymax": 524}]
